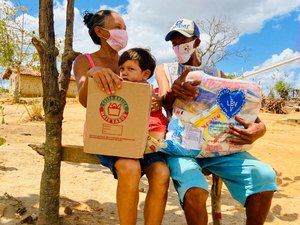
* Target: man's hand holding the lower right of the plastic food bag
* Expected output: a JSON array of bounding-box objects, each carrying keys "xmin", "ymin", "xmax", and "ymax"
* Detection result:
[{"xmin": 227, "ymin": 116, "xmax": 266, "ymax": 145}]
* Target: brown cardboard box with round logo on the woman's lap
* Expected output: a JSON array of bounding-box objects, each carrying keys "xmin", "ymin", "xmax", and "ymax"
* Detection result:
[{"xmin": 84, "ymin": 78, "xmax": 151, "ymax": 158}]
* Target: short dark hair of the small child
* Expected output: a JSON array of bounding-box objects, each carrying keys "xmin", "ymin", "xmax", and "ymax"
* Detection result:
[{"xmin": 118, "ymin": 48, "xmax": 156, "ymax": 78}]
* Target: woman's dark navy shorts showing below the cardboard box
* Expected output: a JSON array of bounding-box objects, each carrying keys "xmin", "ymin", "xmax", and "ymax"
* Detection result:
[{"xmin": 95, "ymin": 152, "xmax": 166, "ymax": 179}]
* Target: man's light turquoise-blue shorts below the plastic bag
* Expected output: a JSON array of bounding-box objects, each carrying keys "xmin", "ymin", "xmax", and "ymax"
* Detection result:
[{"xmin": 167, "ymin": 152, "xmax": 277, "ymax": 206}]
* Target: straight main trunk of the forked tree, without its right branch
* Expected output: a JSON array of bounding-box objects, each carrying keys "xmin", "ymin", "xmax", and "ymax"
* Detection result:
[{"xmin": 33, "ymin": 0, "xmax": 62, "ymax": 225}]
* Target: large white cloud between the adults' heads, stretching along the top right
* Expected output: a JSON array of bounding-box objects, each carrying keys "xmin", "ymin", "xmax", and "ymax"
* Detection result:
[{"xmin": 120, "ymin": 0, "xmax": 300, "ymax": 63}]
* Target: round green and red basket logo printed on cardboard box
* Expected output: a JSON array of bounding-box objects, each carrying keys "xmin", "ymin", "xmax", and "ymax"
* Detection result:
[{"xmin": 99, "ymin": 95, "xmax": 129, "ymax": 124}]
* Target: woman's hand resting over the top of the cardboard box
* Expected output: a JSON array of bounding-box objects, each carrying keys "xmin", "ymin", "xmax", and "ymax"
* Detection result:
[{"xmin": 87, "ymin": 66, "xmax": 122, "ymax": 95}]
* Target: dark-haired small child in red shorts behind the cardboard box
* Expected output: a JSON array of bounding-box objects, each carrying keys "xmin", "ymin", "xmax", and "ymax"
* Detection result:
[{"xmin": 118, "ymin": 48, "xmax": 168, "ymax": 153}]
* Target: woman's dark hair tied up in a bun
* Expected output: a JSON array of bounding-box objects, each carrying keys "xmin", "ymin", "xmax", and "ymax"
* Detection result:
[{"xmin": 83, "ymin": 9, "xmax": 116, "ymax": 45}]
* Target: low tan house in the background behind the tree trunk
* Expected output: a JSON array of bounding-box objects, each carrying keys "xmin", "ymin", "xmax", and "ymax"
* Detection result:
[{"xmin": 3, "ymin": 69, "xmax": 78, "ymax": 98}]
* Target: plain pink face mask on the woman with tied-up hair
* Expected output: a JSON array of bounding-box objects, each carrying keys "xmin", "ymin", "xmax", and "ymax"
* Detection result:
[{"xmin": 102, "ymin": 28, "xmax": 128, "ymax": 52}]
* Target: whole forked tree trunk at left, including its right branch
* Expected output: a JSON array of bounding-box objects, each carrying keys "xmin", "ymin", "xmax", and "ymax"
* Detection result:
[{"xmin": 32, "ymin": 0, "xmax": 77, "ymax": 225}]
